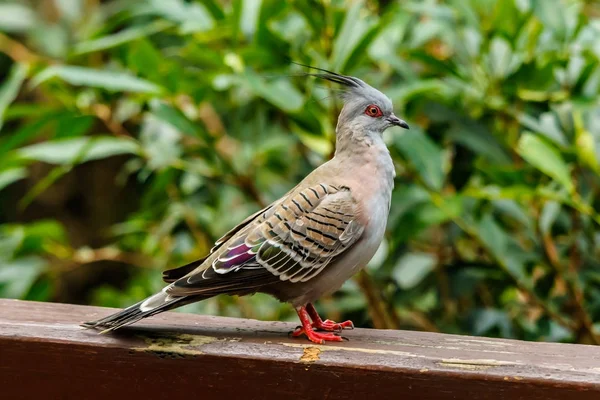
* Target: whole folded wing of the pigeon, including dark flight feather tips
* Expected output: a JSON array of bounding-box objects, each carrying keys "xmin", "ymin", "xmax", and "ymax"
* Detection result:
[{"xmin": 166, "ymin": 184, "xmax": 364, "ymax": 296}]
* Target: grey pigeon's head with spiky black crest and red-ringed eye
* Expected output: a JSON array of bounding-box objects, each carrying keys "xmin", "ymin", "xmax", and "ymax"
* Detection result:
[{"xmin": 310, "ymin": 67, "xmax": 409, "ymax": 134}]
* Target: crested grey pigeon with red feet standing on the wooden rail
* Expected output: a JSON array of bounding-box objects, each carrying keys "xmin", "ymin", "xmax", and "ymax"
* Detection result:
[{"xmin": 82, "ymin": 67, "xmax": 409, "ymax": 344}]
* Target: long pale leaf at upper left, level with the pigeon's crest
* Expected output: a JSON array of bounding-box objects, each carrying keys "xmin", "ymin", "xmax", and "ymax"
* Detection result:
[{"xmin": 31, "ymin": 65, "xmax": 162, "ymax": 94}]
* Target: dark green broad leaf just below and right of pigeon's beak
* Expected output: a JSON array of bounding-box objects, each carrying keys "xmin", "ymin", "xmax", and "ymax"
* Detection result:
[{"xmin": 394, "ymin": 129, "xmax": 445, "ymax": 191}]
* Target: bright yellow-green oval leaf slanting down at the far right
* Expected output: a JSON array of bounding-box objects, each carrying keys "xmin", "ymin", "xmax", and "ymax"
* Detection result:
[{"xmin": 517, "ymin": 132, "xmax": 575, "ymax": 193}]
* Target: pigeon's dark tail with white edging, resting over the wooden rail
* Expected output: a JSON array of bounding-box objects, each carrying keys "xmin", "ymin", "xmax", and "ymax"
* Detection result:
[{"xmin": 81, "ymin": 291, "xmax": 198, "ymax": 333}]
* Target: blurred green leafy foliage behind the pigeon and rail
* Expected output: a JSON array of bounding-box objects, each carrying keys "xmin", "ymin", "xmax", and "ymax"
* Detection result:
[{"xmin": 0, "ymin": 0, "xmax": 600, "ymax": 344}]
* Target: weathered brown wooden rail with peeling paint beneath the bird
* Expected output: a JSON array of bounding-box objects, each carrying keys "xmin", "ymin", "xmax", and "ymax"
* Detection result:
[{"xmin": 0, "ymin": 300, "xmax": 600, "ymax": 400}]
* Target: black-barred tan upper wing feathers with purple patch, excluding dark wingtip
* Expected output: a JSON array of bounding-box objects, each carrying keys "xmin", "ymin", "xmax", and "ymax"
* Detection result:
[{"xmin": 213, "ymin": 184, "xmax": 363, "ymax": 282}]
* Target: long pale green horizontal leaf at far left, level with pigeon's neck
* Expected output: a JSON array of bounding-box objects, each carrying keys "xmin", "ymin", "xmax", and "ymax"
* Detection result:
[{"xmin": 17, "ymin": 136, "xmax": 140, "ymax": 165}]
